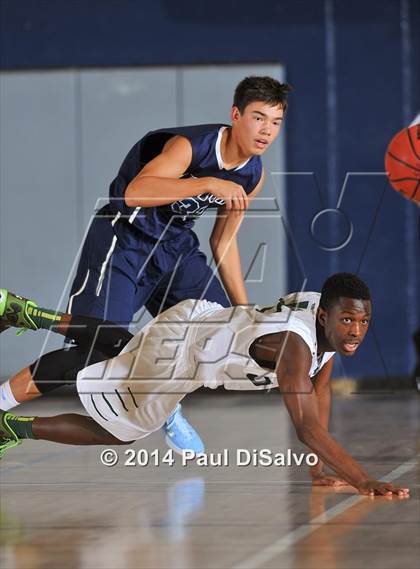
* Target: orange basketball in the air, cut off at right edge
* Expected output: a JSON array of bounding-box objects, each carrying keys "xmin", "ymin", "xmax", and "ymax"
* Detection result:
[{"xmin": 385, "ymin": 123, "xmax": 420, "ymax": 203}]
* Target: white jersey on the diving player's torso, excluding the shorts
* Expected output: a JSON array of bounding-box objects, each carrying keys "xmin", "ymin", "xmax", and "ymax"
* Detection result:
[{"xmin": 188, "ymin": 292, "xmax": 334, "ymax": 390}]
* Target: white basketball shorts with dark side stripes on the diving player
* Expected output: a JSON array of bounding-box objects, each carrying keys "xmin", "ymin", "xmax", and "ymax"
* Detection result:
[{"xmin": 77, "ymin": 300, "xmax": 223, "ymax": 441}]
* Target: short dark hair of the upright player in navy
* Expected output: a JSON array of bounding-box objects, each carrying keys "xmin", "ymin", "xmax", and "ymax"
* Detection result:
[{"xmin": 233, "ymin": 75, "xmax": 292, "ymax": 114}]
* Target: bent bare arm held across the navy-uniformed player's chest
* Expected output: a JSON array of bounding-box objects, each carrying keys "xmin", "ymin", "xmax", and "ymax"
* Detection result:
[{"xmin": 125, "ymin": 136, "xmax": 247, "ymax": 210}]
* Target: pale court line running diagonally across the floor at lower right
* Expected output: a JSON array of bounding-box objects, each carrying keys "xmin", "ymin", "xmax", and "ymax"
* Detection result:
[{"xmin": 232, "ymin": 455, "xmax": 420, "ymax": 569}]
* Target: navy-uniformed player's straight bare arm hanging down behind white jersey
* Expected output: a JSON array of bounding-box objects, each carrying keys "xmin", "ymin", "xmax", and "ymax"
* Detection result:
[{"xmin": 210, "ymin": 172, "xmax": 264, "ymax": 305}]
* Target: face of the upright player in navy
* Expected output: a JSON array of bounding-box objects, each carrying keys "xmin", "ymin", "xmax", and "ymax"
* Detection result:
[{"xmin": 231, "ymin": 101, "xmax": 283, "ymax": 156}]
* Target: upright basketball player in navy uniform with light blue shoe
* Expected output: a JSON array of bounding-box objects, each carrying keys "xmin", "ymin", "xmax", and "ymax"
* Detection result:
[{"xmin": 0, "ymin": 77, "xmax": 290, "ymax": 452}]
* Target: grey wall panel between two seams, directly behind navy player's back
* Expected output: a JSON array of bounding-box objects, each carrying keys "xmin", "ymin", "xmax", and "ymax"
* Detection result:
[{"xmin": 80, "ymin": 68, "xmax": 177, "ymax": 229}]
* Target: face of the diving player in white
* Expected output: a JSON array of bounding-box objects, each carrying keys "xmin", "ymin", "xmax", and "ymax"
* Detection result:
[{"xmin": 318, "ymin": 297, "xmax": 372, "ymax": 356}]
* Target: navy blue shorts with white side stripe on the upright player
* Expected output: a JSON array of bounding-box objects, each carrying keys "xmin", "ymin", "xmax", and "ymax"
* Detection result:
[{"xmin": 68, "ymin": 206, "xmax": 230, "ymax": 326}]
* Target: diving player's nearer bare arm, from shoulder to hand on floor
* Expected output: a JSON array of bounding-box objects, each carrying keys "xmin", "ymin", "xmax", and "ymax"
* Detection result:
[{"xmin": 251, "ymin": 332, "xmax": 408, "ymax": 495}]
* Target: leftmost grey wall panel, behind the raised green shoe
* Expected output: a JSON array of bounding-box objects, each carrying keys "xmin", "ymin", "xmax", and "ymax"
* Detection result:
[{"xmin": 0, "ymin": 71, "xmax": 77, "ymax": 376}]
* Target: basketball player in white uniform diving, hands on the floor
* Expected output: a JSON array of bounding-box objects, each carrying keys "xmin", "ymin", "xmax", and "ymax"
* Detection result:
[{"xmin": 0, "ymin": 273, "xmax": 408, "ymax": 495}]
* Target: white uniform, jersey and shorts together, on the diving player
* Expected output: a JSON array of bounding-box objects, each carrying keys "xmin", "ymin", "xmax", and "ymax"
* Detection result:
[{"xmin": 77, "ymin": 293, "xmax": 333, "ymax": 441}]
